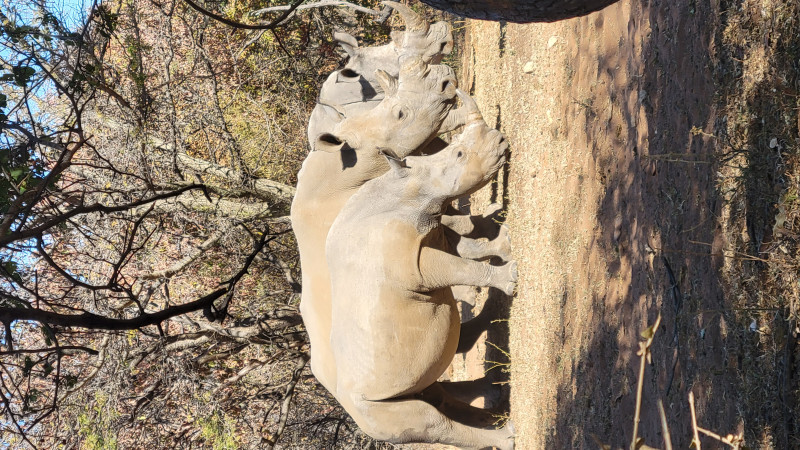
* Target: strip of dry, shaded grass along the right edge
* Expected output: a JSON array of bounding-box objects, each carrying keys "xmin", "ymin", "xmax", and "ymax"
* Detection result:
[{"xmin": 716, "ymin": 0, "xmax": 800, "ymax": 448}]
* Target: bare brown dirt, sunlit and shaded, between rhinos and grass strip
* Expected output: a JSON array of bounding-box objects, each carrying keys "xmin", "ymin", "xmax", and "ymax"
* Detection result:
[{"xmin": 446, "ymin": 0, "xmax": 760, "ymax": 450}]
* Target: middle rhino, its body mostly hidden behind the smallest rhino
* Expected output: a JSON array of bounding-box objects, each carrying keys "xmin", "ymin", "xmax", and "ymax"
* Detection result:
[{"xmin": 291, "ymin": 5, "xmax": 484, "ymax": 398}]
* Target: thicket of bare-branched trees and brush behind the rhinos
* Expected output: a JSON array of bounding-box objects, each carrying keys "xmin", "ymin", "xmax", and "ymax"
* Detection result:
[{"xmin": 0, "ymin": 0, "xmax": 386, "ymax": 448}]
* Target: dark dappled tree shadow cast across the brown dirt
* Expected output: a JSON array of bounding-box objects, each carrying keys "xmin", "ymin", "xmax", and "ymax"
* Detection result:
[{"xmin": 528, "ymin": 0, "xmax": 796, "ymax": 448}]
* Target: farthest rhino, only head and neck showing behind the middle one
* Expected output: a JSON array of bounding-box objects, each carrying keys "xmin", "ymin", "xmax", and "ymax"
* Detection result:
[{"xmin": 307, "ymin": 2, "xmax": 453, "ymax": 146}]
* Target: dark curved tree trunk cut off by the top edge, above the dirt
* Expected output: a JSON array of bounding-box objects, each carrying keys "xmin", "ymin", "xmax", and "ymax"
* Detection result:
[{"xmin": 421, "ymin": 0, "xmax": 617, "ymax": 22}]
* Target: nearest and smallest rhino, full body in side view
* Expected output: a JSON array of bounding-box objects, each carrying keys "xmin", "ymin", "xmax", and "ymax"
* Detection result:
[{"xmin": 326, "ymin": 91, "xmax": 517, "ymax": 450}]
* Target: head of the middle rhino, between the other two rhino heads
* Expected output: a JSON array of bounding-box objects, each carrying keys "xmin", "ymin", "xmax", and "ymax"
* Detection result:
[{"xmin": 314, "ymin": 55, "xmax": 456, "ymax": 162}]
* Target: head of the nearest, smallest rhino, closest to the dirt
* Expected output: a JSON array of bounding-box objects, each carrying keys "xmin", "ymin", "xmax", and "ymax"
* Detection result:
[{"xmin": 384, "ymin": 90, "xmax": 508, "ymax": 201}]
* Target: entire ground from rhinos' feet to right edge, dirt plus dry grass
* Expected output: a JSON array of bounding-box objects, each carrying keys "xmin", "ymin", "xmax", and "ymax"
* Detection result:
[{"xmin": 459, "ymin": 0, "xmax": 800, "ymax": 449}]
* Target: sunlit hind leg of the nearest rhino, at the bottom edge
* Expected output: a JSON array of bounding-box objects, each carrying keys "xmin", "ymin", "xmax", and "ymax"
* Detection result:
[{"xmin": 342, "ymin": 388, "xmax": 514, "ymax": 450}]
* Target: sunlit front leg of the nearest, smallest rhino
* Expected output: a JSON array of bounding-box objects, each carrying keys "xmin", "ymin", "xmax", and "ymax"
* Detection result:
[{"xmin": 419, "ymin": 247, "xmax": 517, "ymax": 295}]
